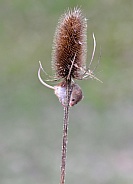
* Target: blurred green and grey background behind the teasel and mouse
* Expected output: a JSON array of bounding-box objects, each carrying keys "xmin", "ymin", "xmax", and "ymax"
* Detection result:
[{"xmin": 0, "ymin": 0, "xmax": 133, "ymax": 184}]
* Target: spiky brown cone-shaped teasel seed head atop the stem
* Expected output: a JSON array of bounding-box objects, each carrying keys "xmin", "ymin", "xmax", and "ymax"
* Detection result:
[{"xmin": 52, "ymin": 8, "xmax": 87, "ymax": 79}]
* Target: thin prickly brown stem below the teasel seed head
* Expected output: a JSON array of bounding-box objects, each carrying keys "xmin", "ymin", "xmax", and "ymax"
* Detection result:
[{"xmin": 60, "ymin": 79, "xmax": 71, "ymax": 184}]
